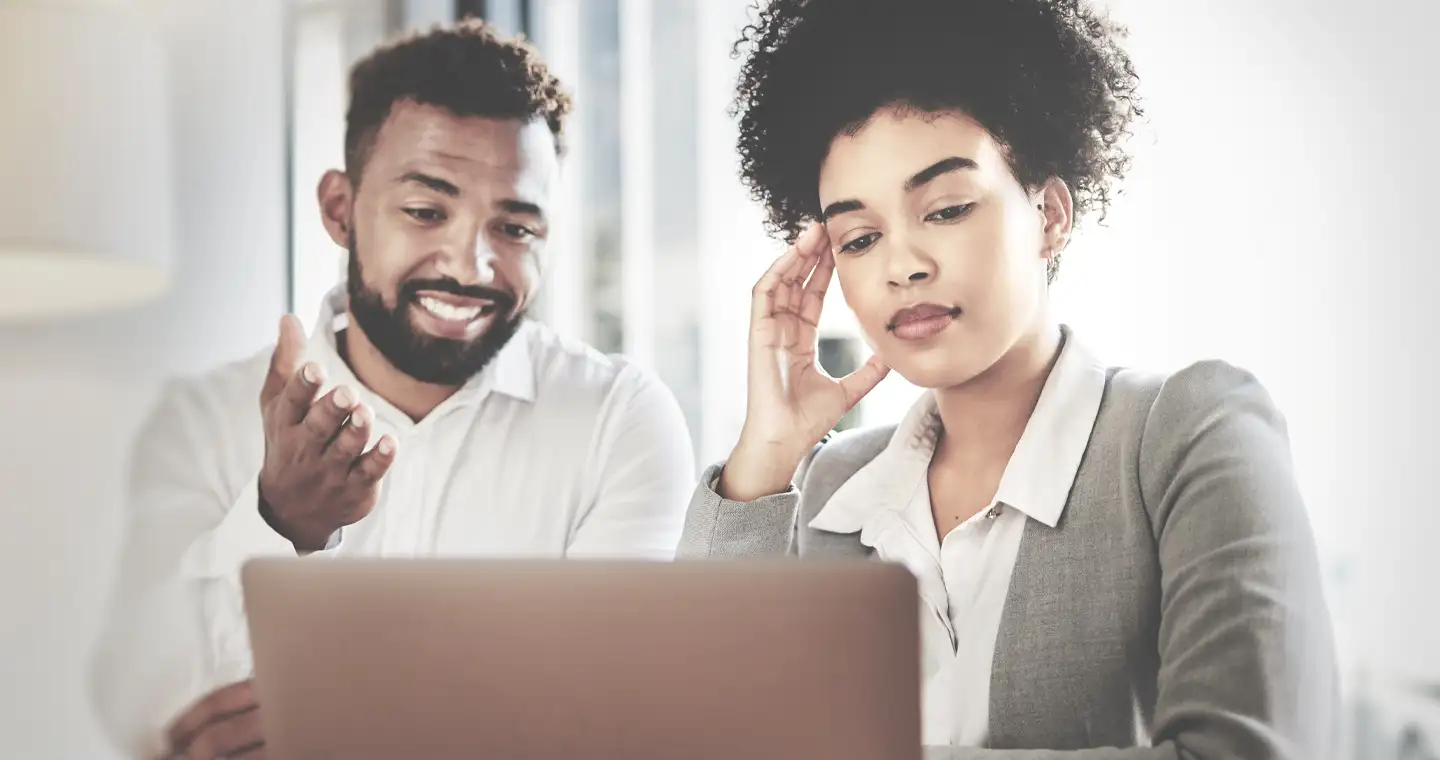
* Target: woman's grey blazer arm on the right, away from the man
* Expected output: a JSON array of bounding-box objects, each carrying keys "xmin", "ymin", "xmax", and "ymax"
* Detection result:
[{"xmin": 926, "ymin": 363, "xmax": 1339, "ymax": 760}]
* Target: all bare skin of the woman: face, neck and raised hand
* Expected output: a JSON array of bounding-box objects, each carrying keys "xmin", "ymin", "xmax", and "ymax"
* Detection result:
[{"xmin": 719, "ymin": 108, "xmax": 1074, "ymax": 537}]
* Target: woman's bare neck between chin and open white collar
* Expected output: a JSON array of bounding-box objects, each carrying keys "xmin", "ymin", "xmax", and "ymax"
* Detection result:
[{"xmin": 935, "ymin": 324, "xmax": 1061, "ymax": 459}]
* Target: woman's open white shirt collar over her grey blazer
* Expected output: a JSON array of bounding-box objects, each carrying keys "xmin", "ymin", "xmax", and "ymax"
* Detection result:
[{"xmin": 809, "ymin": 327, "xmax": 1107, "ymax": 538}]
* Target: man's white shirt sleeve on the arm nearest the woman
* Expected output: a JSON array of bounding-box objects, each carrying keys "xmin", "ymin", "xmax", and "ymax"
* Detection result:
[{"xmin": 566, "ymin": 366, "xmax": 696, "ymax": 560}]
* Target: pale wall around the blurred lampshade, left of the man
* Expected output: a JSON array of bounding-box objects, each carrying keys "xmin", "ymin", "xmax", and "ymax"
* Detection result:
[{"xmin": 0, "ymin": 0, "xmax": 285, "ymax": 759}]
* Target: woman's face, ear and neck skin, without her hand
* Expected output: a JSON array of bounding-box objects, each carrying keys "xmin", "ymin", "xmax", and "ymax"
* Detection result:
[{"xmin": 819, "ymin": 109, "xmax": 1073, "ymax": 537}]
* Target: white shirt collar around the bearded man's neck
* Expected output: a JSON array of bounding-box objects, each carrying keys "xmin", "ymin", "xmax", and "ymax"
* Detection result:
[{"xmin": 305, "ymin": 284, "xmax": 539, "ymax": 404}]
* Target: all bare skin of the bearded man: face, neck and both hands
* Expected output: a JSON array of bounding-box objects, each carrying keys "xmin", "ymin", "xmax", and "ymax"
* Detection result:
[{"xmin": 168, "ymin": 102, "xmax": 559, "ymax": 760}]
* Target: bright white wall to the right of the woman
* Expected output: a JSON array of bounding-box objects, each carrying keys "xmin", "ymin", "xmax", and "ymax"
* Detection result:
[{"xmin": 1088, "ymin": 0, "xmax": 1440, "ymax": 693}]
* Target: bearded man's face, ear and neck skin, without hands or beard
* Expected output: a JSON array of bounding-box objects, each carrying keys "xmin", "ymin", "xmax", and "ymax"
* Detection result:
[{"xmin": 318, "ymin": 102, "xmax": 559, "ymax": 419}]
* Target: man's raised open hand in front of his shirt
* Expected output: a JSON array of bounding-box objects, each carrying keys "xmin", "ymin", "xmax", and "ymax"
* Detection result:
[{"xmin": 259, "ymin": 314, "xmax": 396, "ymax": 551}]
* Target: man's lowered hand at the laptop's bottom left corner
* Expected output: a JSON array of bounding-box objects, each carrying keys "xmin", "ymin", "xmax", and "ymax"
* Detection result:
[{"xmin": 168, "ymin": 681, "xmax": 265, "ymax": 760}]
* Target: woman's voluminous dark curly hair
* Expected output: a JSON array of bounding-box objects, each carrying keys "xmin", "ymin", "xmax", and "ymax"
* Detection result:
[{"xmin": 732, "ymin": 0, "xmax": 1142, "ymax": 276}]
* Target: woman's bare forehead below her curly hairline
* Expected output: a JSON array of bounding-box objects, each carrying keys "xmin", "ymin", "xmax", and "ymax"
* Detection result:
[{"xmin": 819, "ymin": 108, "xmax": 1009, "ymax": 203}]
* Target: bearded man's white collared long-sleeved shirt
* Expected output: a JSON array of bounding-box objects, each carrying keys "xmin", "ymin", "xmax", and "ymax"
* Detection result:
[{"xmin": 95, "ymin": 288, "xmax": 694, "ymax": 753}]
